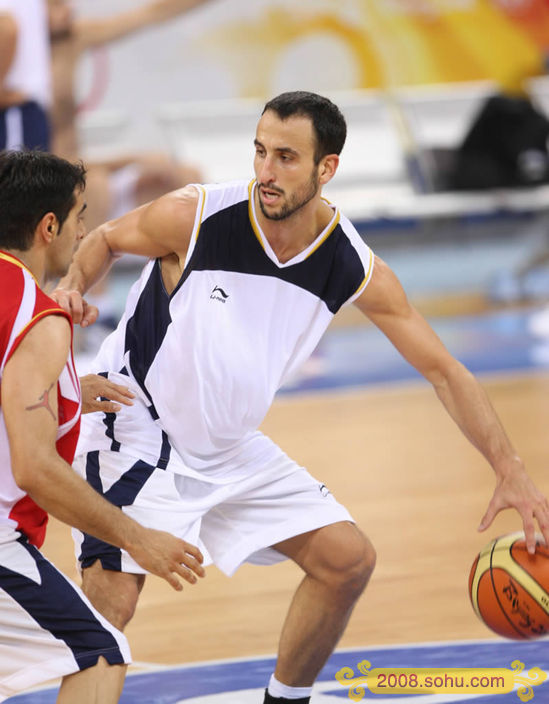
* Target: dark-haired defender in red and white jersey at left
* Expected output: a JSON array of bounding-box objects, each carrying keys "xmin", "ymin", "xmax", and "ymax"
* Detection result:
[{"xmin": 0, "ymin": 151, "xmax": 203, "ymax": 704}]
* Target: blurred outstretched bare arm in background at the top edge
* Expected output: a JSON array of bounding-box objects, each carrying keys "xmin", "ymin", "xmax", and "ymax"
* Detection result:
[{"xmin": 74, "ymin": 0, "xmax": 214, "ymax": 51}]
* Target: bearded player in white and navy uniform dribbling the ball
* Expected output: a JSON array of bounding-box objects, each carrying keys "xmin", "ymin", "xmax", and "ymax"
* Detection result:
[{"xmin": 55, "ymin": 91, "xmax": 549, "ymax": 704}]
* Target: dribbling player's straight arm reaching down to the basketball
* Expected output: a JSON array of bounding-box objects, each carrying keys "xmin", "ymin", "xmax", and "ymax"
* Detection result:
[{"xmin": 355, "ymin": 257, "xmax": 549, "ymax": 552}]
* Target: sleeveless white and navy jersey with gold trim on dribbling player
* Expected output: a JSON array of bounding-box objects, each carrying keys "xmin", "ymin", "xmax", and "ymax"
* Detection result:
[{"xmin": 79, "ymin": 181, "xmax": 373, "ymax": 476}]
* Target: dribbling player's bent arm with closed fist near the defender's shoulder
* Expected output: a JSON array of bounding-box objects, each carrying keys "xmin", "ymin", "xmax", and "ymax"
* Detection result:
[{"xmin": 51, "ymin": 186, "xmax": 199, "ymax": 327}]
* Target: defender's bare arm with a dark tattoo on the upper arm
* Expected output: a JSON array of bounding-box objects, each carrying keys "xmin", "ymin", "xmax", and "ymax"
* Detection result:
[{"xmin": 2, "ymin": 315, "xmax": 203, "ymax": 590}]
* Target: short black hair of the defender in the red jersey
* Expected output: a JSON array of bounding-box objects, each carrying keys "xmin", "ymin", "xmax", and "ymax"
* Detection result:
[{"xmin": 0, "ymin": 150, "xmax": 86, "ymax": 251}]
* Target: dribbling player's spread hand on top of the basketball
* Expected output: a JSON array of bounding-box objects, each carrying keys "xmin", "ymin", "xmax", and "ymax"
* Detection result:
[{"xmin": 478, "ymin": 468, "xmax": 549, "ymax": 554}]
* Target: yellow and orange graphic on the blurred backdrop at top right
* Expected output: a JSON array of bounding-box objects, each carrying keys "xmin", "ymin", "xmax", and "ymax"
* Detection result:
[{"xmin": 195, "ymin": 0, "xmax": 549, "ymax": 98}]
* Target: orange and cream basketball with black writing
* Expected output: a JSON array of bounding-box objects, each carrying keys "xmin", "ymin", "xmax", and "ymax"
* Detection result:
[{"xmin": 469, "ymin": 533, "xmax": 549, "ymax": 640}]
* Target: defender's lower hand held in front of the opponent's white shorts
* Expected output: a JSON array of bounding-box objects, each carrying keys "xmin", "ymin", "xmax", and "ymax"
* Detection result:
[{"xmin": 128, "ymin": 528, "xmax": 206, "ymax": 592}]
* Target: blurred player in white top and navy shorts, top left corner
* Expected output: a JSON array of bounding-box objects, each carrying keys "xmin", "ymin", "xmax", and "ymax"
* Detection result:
[{"xmin": 0, "ymin": 0, "xmax": 51, "ymax": 149}]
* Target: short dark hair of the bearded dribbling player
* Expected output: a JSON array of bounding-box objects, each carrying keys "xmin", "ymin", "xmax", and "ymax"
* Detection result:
[{"xmin": 262, "ymin": 90, "xmax": 347, "ymax": 164}]
